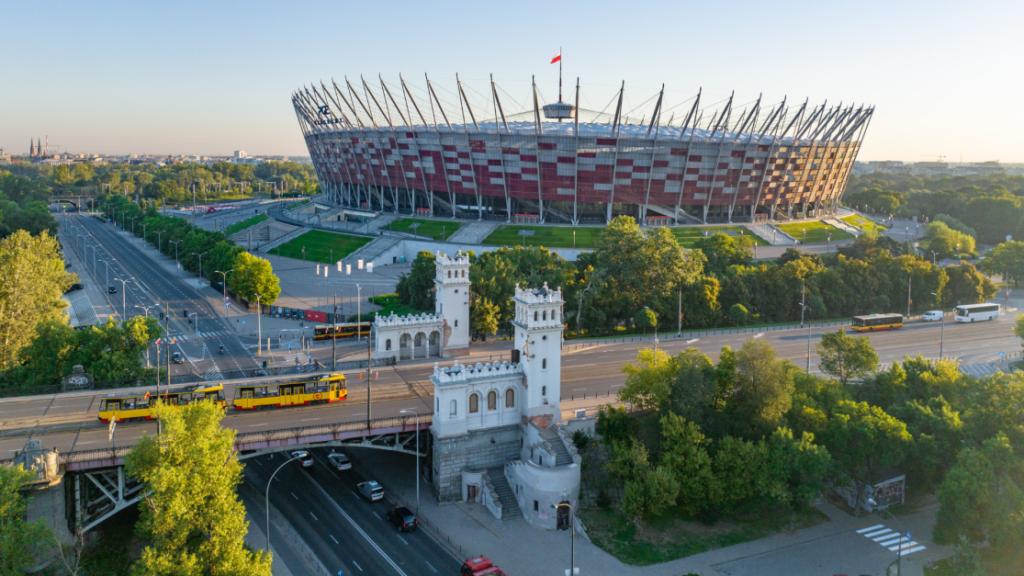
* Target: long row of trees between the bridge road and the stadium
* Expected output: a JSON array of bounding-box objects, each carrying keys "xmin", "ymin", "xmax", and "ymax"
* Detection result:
[{"xmin": 389, "ymin": 216, "xmax": 991, "ymax": 337}]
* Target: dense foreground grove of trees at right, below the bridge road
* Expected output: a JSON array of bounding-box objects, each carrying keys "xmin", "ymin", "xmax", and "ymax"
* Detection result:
[{"xmin": 598, "ymin": 330, "xmax": 1024, "ymax": 544}]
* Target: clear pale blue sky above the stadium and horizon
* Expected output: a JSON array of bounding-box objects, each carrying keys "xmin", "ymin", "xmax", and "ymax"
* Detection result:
[{"xmin": 0, "ymin": 0, "xmax": 1024, "ymax": 162}]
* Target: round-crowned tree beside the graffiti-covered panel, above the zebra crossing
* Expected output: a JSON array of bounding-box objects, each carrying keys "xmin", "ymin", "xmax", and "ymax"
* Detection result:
[{"xmin": 822, "ymin": 401, "xmax": 912, "ymax": 513}]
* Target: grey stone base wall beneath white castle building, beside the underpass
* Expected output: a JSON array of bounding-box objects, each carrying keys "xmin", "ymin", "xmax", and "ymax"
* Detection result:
[{"xmin": 431, "ymin": 424, "xmax": 522, "ymax": 502}]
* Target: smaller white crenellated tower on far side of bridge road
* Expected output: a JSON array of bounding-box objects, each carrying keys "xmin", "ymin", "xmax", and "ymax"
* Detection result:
[{"xmin": 434, "ymin": 250, "xmax": 471, "ymax": 357}]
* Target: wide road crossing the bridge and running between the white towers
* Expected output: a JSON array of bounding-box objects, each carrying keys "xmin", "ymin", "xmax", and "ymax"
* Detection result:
[{"xmin": 0, "ymin": 305, "xmax": 1021, "ymax": 457}]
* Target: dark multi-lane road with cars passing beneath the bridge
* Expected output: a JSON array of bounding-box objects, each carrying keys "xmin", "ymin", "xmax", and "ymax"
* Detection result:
[{"xmin": 245, "ymin": 449, "xmax": 460, "ymax": 576}]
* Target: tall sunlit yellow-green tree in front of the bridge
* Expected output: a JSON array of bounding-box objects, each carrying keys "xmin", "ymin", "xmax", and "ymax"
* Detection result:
[{"xmin": 125, "ymin": 401, "xmax": 270, "ymax": 576}]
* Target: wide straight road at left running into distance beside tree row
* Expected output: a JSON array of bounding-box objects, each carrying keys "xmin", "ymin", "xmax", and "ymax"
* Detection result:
[{"xmin": 70, "ymin": 211, "xmax": 258, "ymax": 378}]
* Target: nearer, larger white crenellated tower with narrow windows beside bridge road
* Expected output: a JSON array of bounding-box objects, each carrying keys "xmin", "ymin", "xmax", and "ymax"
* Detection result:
[{"xmin": 512, "ymin": 282, "xmax": 564, "ymax": 428}]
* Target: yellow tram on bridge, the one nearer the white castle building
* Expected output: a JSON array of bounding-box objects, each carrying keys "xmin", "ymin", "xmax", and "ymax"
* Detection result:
[{"xmin": 232, "ymin": 373, "xmax": 348, "ymax": 410}]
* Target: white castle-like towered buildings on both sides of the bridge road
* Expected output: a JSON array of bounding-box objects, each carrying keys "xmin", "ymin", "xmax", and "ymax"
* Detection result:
[{"xmin": 374, "ymin": 253, "xmax": 581, "ymax": 530}]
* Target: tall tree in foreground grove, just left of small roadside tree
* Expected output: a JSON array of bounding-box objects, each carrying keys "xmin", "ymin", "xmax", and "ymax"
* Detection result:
[{"xmin": 729, "ymin": 339, "xmax": 798, "ymax": 438}]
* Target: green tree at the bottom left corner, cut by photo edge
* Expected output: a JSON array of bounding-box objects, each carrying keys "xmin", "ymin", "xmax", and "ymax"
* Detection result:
[{"xmin": 0, "ymin": 466, "xmax": 46, "ymax": 576}]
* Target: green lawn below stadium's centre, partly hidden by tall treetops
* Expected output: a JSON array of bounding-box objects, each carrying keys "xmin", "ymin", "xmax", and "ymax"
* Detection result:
[{"xmin": 482, "ymin": 224, "xmax": 768, "ymax": 248}]
